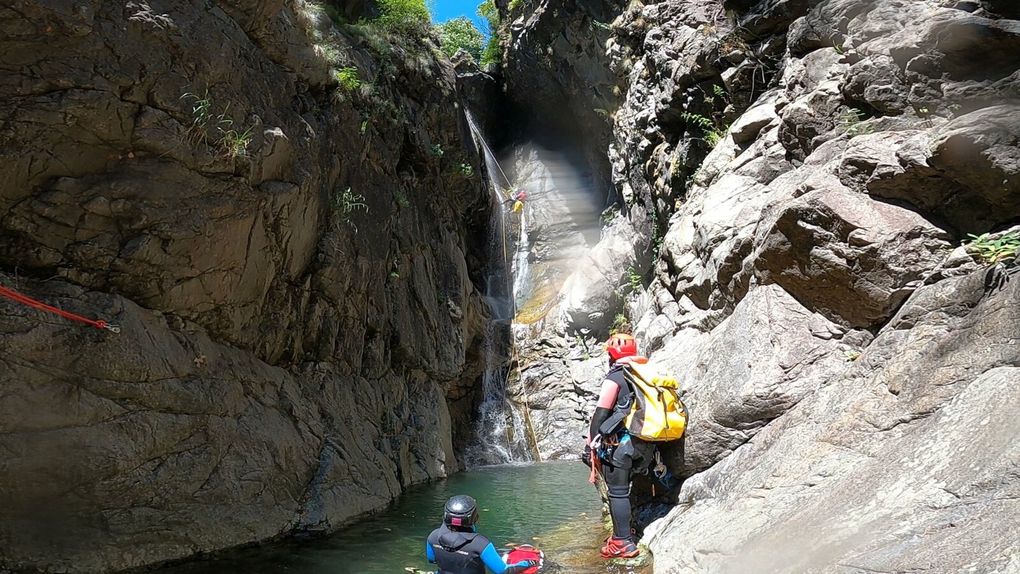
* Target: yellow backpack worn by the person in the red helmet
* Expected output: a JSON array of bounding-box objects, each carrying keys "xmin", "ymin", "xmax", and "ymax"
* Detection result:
[{"xmin": 623, "ymin": 362, "xmax": 687, "ymax": 441}]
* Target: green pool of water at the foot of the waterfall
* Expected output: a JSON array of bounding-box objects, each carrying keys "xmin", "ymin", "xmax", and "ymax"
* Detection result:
[{"xmin": 163, "ymin": 462, "xmax": 648, "ymax": 574}]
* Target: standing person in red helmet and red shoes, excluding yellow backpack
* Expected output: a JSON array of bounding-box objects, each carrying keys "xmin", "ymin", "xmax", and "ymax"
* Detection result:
[{"xmin": 582, "ymin": 333, "xmax": 655, "ymax": 558}]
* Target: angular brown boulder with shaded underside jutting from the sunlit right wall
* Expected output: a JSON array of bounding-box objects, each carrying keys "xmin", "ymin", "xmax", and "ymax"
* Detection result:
[{"xmin": 748, "ymin": 190, "xmax": 952, "ymax": 328}]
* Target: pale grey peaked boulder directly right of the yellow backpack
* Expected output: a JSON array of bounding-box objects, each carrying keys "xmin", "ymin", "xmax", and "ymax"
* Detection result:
[{"xmin": 651, "ymin": 285, "xmax": 870, "ymax": 477}]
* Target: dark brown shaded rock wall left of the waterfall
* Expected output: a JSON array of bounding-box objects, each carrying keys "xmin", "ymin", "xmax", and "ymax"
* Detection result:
[{"xmin": 0, "ymin": 0, "xmax": 491, "ymax": 572}]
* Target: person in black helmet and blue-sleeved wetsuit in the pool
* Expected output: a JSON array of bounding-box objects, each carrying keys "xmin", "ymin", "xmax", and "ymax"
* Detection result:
[{"xmin": 425, "ymin": 494, "xmax": 540, "ymax": 574}]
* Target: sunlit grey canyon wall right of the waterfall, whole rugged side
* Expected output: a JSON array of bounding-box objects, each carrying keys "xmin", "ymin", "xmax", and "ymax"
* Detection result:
[{"xmin": 499, "ymin": 0, "xmax": 1020, "ymax": 573}]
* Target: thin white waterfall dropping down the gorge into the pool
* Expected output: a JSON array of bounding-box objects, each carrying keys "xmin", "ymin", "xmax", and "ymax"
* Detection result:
[{"xmin": 464, "ymin": 108, "xmax": 531, "ymax": 467}]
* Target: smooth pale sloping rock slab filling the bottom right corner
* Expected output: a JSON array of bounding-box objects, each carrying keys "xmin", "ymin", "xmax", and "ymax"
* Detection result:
[{"xmin": 648, "ymin": 272, "xmax": 1020, "ymax": 572}]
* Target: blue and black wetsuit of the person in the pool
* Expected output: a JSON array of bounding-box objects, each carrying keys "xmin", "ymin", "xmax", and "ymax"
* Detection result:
[{"xmin": 425, "ymin": 524, "xmax": 530, "ymax": 574}]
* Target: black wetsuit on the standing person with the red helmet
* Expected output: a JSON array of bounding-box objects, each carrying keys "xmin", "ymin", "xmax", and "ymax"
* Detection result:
[{"xmin": 589, "ymin": 364, "xmax": 655, "ymax": 538}]
